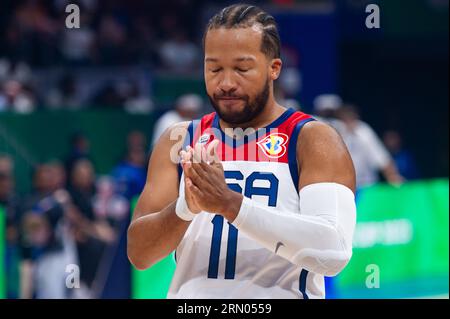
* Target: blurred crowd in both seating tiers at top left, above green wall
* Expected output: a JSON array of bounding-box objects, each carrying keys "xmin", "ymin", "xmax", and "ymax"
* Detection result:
[{"xmin": 0, "ymin": 0, "xmax": 203, "ymax": 113}]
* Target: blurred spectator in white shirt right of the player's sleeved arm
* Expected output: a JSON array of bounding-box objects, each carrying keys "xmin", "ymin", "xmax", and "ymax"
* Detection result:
[{"xmin": 336, "ymin": 105, "xmax": 403, "ymax": 188}]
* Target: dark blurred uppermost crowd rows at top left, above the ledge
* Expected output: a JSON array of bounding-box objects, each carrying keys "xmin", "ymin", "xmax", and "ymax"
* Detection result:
[{"xmin": 0, "ymin": 0, "xmax": 202, "ymax": 69}]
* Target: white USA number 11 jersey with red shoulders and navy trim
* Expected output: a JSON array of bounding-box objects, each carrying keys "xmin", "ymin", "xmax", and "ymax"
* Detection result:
[{"xmin": 167, "ymin": 109, "xmax": 325, "ymax": 299}]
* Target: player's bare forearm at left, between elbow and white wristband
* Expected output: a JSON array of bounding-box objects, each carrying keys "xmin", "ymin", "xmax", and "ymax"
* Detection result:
[{"xmin": 127, "ymin": 201, "xmax": 190, "ymax": 270}]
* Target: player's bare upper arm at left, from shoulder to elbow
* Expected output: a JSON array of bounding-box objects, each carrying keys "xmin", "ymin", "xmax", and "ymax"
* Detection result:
[{"xmin": 133, "ymin": 122, "xmax": 189, "ymax": 224}]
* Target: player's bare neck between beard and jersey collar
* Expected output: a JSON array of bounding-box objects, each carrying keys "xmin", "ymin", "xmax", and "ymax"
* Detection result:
[{"xmin": 219, "ymin": 96, "xmax": 286, "ymax": 130}]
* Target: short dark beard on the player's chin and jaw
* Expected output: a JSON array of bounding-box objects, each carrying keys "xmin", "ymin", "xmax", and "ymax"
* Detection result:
[{"xmin": 208, "ymin": 79, "xmax": 270, "ymax": 125}]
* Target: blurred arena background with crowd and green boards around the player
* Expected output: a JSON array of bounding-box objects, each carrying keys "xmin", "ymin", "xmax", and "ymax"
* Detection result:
[{"xmin": 0, "ymin": 0, "xmax": 449, "ymax": 298}]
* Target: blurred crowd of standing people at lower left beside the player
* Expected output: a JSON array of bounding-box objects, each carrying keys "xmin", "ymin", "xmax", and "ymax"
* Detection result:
[{"xmin": 0, "ymin": 131, "xmax": 147, "ymax": 298}]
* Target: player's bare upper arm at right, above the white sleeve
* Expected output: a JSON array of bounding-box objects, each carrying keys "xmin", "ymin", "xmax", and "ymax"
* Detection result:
[{"xmin": 297, "ymin": 121, "xmax": 355, "ymax": 192}]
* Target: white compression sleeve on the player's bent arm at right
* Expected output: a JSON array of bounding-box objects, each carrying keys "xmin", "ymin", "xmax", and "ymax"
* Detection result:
[{"xmin": 224, "ymin": 184, "xmax": 356, "ymax": 276}]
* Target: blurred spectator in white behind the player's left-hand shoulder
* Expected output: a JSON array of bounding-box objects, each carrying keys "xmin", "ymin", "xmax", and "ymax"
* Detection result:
[{"xmin": 152, "ymin": 94, "xmax": 203, "ymax": 148}]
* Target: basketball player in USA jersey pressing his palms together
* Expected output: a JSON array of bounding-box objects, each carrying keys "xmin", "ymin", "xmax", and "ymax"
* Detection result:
[{"xmin": 128, "ymin": 5, "xmax": 356, "ymax": 299}]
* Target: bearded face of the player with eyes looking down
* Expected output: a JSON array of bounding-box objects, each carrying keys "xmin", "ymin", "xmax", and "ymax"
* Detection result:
[{"xmin": 205, "ymin": 27, "xmax": 281, "ymax": 124}]
